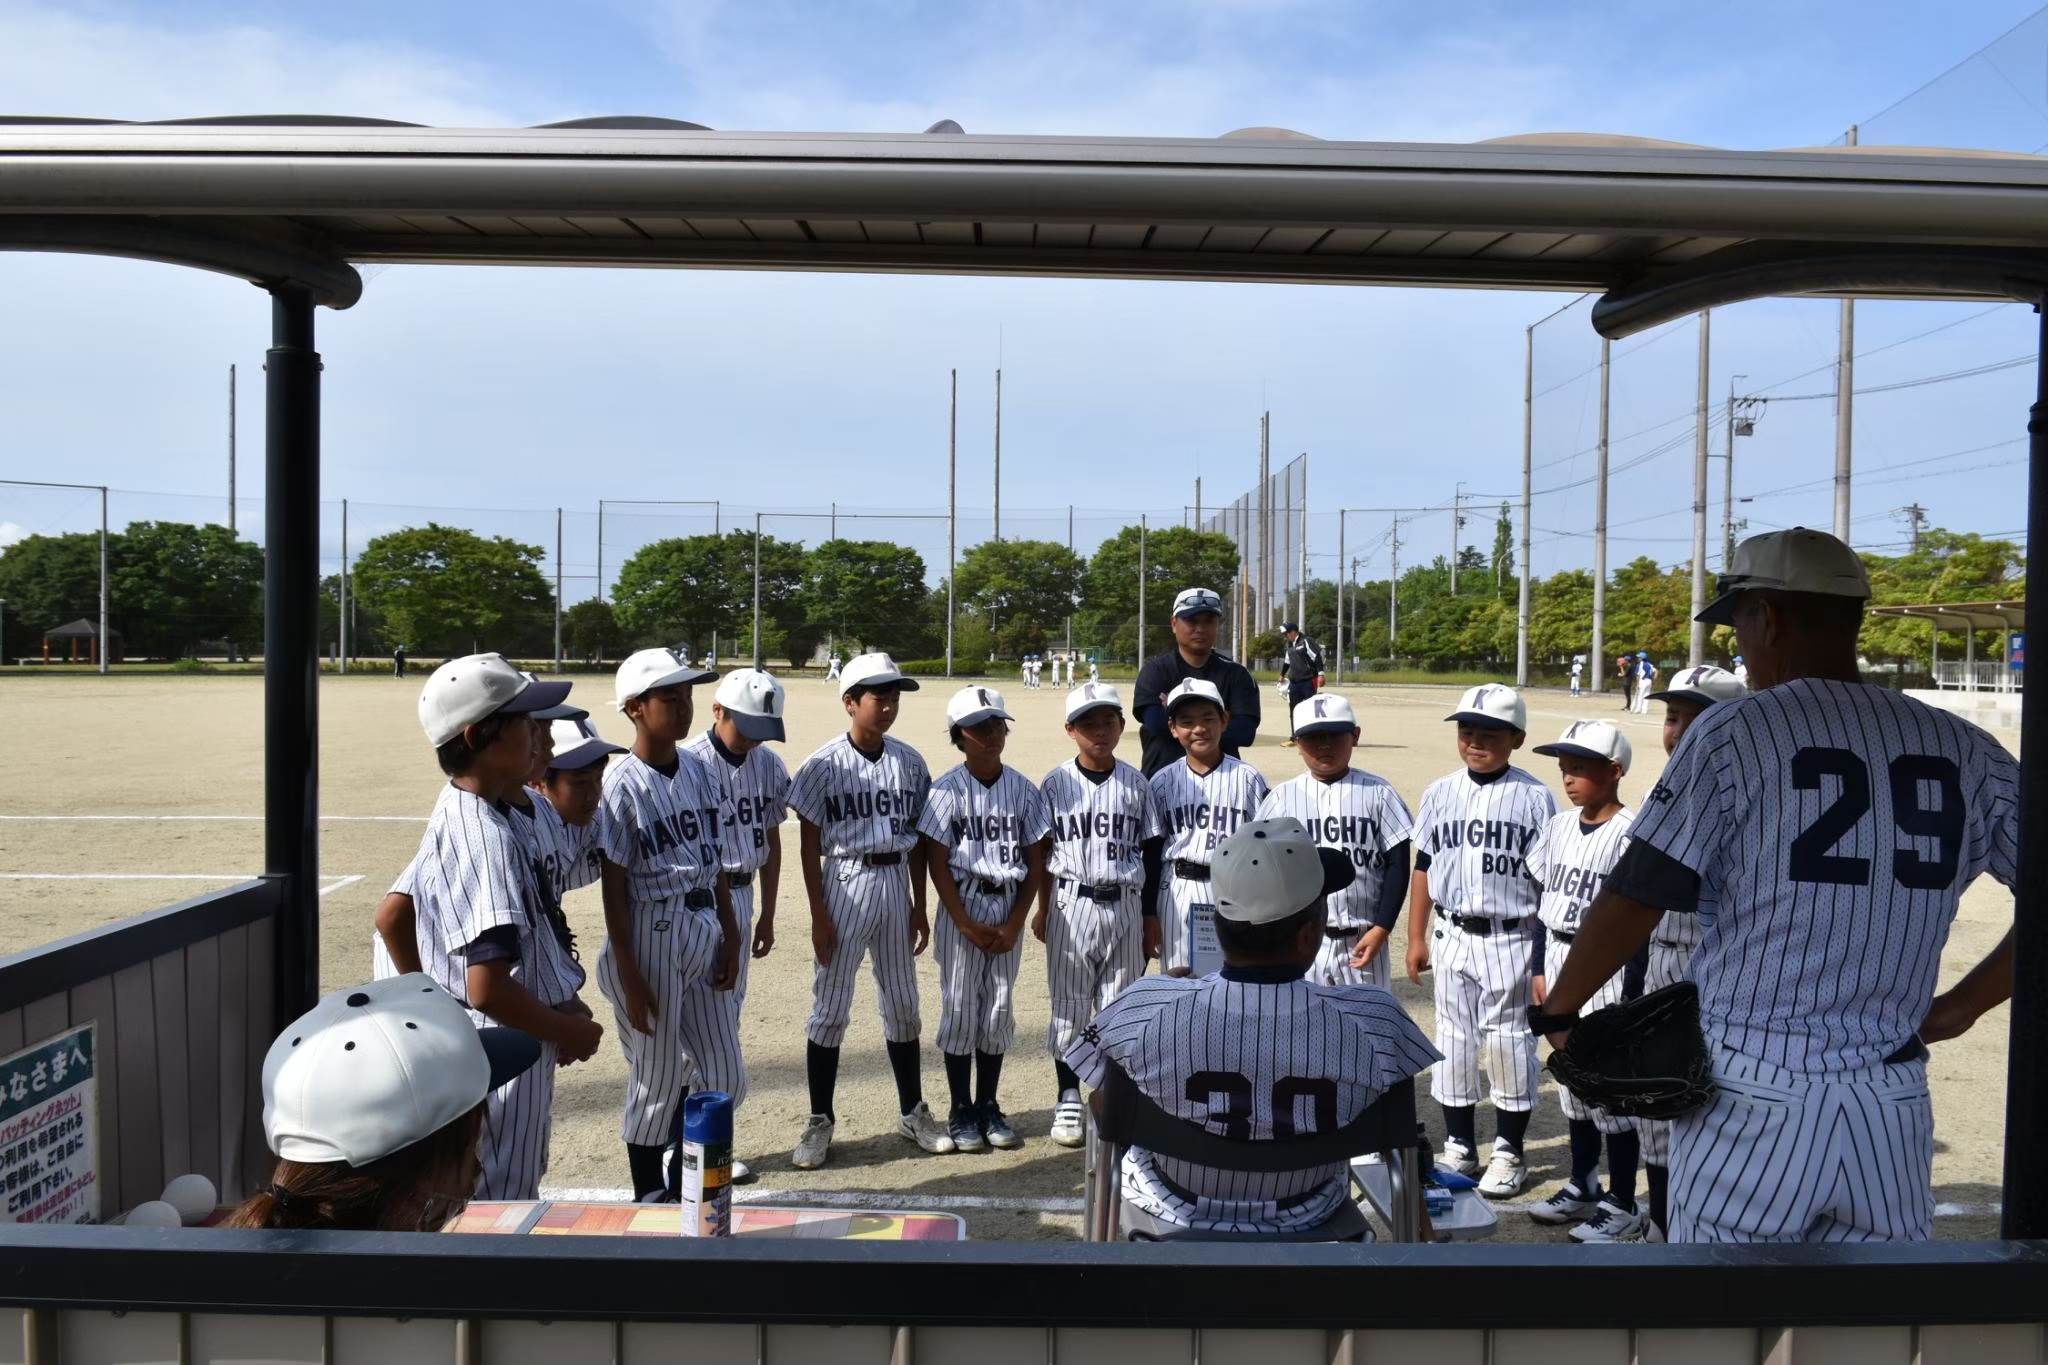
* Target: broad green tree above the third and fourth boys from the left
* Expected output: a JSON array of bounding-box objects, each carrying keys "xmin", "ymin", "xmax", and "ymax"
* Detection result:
[{"xmin": 612, "ymin": 530, "xmax": 805, "ymax": 651}]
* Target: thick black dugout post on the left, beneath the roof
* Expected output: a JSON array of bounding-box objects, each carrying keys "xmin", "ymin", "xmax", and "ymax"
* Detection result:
[{"xmin": 262, "ymin": 287, "xmax": 319, "ymax": 1035}]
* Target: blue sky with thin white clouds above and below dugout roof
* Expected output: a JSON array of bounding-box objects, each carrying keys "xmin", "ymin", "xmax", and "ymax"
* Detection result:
[{"xmin": 0, "ymin": 0, "xmax": 2048, "ymax": 600}]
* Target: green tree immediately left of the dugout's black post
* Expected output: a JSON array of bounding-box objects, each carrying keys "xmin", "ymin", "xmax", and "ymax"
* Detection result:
[{"xmin": 109, "ymin": 522, "xmax": 262, "ymax": 659}]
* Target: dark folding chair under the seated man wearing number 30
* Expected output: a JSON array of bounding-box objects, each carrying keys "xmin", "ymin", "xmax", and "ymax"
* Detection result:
[{"xmin": 1085, "ymin": 1062, "xmax": 1421, "ymax": 1242}]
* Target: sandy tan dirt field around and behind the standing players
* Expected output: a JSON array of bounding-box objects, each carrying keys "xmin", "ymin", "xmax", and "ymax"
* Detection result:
[{"xmin": 0, "ymin": 675, "xmax": 2011, "ymax": 1240}]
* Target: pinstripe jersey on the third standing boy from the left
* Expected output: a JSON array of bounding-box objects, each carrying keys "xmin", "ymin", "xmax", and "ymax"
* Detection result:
[{"xmin": 598, "ymin": 749, "xmax": 727, "ymax": 905}]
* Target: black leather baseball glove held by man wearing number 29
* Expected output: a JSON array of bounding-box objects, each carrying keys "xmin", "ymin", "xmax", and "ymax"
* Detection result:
[{"xmin": 1548, "ymin": 980, "xmax": 1714, "ymax": 1119}]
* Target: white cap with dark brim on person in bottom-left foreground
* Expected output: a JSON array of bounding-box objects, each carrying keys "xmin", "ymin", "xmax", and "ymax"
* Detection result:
[{"xmin": 262, "ymin": 972, "xmax": 541, "ymax": 1166}]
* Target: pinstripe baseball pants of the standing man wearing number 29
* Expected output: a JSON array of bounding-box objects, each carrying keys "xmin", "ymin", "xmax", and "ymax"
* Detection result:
[{"xmin": 1671, "ymin": 1048, "xmax": 1933, "ymax": 1242}]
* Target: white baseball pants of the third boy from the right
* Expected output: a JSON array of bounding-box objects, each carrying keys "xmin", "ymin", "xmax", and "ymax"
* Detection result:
[{"xmin": 1430, "ymin": 911, "xmax": 1538, "ymax": 1113}]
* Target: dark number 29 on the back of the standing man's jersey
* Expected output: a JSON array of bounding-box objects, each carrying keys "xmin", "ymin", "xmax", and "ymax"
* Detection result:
[{"xmin": 1788, "ymin": 749, "xmax": 1964, "ymax": 890}]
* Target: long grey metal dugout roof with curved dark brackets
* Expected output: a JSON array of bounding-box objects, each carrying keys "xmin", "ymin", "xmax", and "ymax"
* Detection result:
[{"xmin": 12, "ymin": 117, "xmax": 2048, "ymax": 336}]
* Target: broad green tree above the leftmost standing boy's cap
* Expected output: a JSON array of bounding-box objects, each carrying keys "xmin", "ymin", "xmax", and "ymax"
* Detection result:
[{"xmin": 354, "ymin": 522, "xmax": 555, "ymax": 655}]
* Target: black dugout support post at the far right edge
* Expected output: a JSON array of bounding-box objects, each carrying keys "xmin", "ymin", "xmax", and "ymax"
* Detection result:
[{"xmin": 1999, "ymin": 296, "xmax": 2048, "ymax": 1238}]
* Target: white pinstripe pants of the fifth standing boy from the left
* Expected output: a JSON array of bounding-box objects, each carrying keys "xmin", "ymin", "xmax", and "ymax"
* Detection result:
[{"xmin": 805, "ymin": 857, "xmax": 922, "ymax": 1048}]
